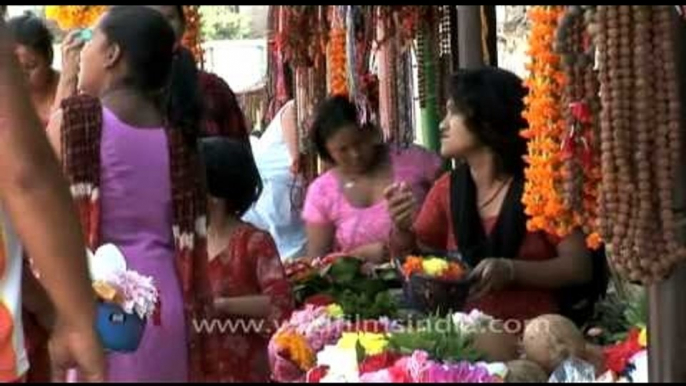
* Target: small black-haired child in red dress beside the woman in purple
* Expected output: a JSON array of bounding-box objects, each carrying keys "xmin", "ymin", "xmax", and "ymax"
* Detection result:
[{"xmin": 200, "ymin": 137, "xmax": 294, "ymax": 382}]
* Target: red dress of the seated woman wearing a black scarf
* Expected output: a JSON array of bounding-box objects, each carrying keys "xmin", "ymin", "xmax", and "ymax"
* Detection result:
[{"xmin": 414, "ymin": 173, "xmax": 560, "ymax": 322}]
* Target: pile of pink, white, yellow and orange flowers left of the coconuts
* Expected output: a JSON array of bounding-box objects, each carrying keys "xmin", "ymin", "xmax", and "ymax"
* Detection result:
[{"xmin": 269, "ymin": 304, "xmax": 506, "ymax": 383}]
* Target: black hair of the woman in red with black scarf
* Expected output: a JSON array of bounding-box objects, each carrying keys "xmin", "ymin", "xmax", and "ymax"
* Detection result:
[{"xmin": 449, "ymin": 67, "xmax": 527, "ymax": 177}]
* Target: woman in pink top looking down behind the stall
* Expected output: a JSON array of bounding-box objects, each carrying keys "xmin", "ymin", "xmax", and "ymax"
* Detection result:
[{"xmin": 302, "ymin": 97, "xmax": 441, "ymax": 263}]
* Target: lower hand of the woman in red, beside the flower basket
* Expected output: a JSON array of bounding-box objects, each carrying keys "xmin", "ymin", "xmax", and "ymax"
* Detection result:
[{"xmin": 469, "ymin": 258, "xmax": 515, "ymax": 299}]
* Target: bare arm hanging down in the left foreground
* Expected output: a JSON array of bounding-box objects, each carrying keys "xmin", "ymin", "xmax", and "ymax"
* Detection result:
[{"xmin": 0, "ymin": 21, "xmax": 105, "ymax": 381}]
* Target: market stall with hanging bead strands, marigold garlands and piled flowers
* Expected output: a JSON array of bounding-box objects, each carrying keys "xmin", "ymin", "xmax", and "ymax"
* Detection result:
[{"xmin": 33, "ymin": 5, "xmax": 686, "ymax": 383}]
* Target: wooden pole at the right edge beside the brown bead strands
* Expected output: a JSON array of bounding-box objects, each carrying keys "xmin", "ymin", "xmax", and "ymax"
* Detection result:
[{"xmin": 648, "ymin": 6, "xmax": 686, "ymax": 382}]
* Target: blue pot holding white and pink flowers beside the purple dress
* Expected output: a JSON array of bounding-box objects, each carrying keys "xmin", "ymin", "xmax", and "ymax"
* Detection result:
[{"xmin": 88, "ymin": 244, "xmax": 159, "ymax": 352}]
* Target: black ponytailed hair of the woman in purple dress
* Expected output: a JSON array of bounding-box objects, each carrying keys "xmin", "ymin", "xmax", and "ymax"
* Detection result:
[{"xmin": 101, "ymin": 6, "xmax": 203, "ymax": 148}]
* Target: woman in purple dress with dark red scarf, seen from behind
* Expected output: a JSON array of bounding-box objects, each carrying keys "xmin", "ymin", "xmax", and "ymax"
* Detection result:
[{"xmin": 48, "ymin": 6, "xmax": 209, "ymax": 382}]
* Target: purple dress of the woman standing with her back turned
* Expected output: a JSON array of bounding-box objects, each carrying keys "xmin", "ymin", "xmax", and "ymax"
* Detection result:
[{"xmin": 100, "ymin": 108, "xmax": 188, "ymax": 382}]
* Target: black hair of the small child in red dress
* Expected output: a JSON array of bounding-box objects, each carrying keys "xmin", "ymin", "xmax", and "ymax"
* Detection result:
[{"xmin": 199, "ymin": 137, "xmax": 262, "ymax": 216}]
